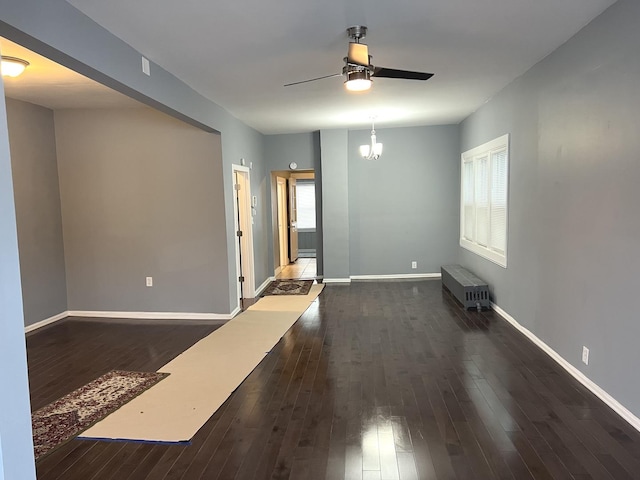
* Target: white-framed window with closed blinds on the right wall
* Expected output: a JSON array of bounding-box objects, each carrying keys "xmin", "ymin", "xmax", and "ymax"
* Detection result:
[{"xmin": 460, "ymin": 135, "xmax": 509, "ymax": 268}]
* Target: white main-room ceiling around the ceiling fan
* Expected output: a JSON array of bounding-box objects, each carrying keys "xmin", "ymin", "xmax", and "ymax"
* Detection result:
[{"xmin": 3, "ymin": 0, "xmax": 615, "ymax": 134}]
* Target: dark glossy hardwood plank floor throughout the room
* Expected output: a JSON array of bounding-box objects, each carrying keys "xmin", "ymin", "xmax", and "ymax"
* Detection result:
[{"xmin": 27, "ymin": 281, "xmax": 640, "ymax": 480}]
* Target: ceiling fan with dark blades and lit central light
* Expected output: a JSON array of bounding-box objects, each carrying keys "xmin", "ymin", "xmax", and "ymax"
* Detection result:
[{"xmin": 285, "ymin": 25, "xmax": 433, "ymax": 91}]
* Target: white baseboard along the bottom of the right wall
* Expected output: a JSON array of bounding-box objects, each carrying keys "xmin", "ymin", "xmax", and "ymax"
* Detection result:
[{"xmin": 491, "ymin": 302, "xmax": 640, "ymax": 431}]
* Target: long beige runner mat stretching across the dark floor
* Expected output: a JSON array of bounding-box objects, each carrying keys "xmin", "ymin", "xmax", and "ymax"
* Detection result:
[{"xmin": 80, "ymin": 285, "xmax": 324, "ymax": 443}]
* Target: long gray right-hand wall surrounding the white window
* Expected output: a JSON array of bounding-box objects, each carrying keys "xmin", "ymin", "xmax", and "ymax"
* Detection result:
[{"xmin": 460, "ymin": 0, "xmax": 640, "ymax": 416}]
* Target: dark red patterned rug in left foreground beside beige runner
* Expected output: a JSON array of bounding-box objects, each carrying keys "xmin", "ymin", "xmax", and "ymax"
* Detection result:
[{"xmin": 31, "ymin": 370, "xmax": 169, "ymax": 460}]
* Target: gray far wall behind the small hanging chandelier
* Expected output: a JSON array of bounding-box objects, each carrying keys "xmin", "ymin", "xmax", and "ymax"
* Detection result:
[{"xmin": 348, "ymin": 125, "xmax": 460, "ymax": 275}]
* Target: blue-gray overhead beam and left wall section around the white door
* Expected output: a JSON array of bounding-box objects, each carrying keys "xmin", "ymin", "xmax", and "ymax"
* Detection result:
[{"xmin": 0, "ymin": 0, "xmax": 268, "ymax": 311}]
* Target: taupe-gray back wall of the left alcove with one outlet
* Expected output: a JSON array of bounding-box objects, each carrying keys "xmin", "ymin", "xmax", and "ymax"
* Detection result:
[{"xmin": 55, "ymin": 108, "xmax": 229, "ymax": 313}]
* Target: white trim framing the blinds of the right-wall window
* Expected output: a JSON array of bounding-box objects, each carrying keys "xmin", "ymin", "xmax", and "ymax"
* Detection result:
[{"xmin": 460, "ymin": 134, "xmax": 511, "ymax": 268}]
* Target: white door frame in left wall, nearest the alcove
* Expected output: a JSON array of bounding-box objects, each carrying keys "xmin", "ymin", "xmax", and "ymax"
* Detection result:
[{"xmin": 231, "ymin": 164, "xmax": 256, "ymax": 298}]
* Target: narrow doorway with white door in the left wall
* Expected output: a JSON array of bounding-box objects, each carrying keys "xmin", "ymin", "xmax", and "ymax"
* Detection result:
[{"xmin": 233, "ymin": 165, "xmax": 255, "ymax": 307}]
